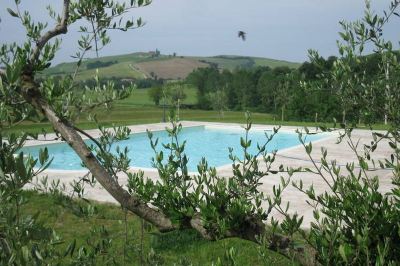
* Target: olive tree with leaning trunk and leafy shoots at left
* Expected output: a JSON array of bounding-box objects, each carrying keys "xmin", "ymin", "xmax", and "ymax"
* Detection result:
[{"xmin": 0, "ymin": 0, "xmax": 288, "ymax": 256}]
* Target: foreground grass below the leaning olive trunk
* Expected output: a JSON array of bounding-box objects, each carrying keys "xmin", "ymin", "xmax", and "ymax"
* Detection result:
[{"xmin": 22, "ymin": 192, "xmax": 290, "ymax": 265}]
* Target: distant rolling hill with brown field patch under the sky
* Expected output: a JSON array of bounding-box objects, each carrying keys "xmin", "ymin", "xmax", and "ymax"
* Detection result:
[{"xmin": 43, "ymin": 52, "xmax": 300, "ymax": 80}]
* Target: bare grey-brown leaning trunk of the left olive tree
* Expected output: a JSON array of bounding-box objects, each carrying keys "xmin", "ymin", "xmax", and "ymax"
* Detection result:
[{"xmin": 16, "ymin": 0, "xmax": 176, "ymax": 231}]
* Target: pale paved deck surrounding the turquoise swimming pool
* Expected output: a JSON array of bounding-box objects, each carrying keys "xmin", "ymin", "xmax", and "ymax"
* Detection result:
[{"xmin": 26, "ymin": 121, "xmax": 392, "ymax": 227}]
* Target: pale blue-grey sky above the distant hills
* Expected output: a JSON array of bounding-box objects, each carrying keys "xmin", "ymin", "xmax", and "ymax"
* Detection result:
[{"xmin": 0, "ymin": 0, "xmax": 400, "ymax": 63}]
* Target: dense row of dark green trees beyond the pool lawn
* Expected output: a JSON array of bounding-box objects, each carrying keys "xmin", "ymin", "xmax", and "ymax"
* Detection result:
[{"xmin": 186, "ymin": 54, "xmax": 390, "ymax": 122}]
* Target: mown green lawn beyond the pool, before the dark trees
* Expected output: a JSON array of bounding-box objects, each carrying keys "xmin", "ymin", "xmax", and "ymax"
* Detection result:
[{"xmin": 5, "ymin": 102, "xmax": 388, "ymax": 133}]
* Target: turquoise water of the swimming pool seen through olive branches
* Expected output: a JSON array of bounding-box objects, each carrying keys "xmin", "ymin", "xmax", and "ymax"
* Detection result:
[{"xmin": 22, "ymin": 126, "xmax": 326, "ymax": 171}]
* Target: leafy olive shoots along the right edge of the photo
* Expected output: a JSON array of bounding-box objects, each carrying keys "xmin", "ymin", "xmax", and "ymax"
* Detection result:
[{"xmin": 277, "ymin": 0, "xmax": 400, "ymax": 265}]
